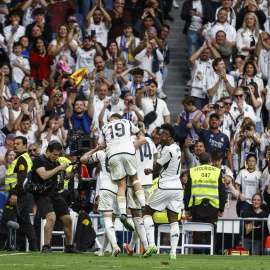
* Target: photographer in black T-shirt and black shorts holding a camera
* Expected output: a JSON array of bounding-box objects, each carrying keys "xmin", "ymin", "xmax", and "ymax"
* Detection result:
[{"xmin": 33, "ymin": 140, "xmax": 81, "ymax": 253}]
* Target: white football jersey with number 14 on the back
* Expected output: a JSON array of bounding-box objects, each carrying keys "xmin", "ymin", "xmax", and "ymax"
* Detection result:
[{"xmin": 132, "ymin": 137, "xmax": 157, "ymax": 186}]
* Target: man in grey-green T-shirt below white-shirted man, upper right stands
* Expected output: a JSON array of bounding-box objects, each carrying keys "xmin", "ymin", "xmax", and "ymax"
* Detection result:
[{"xmin": 212, "ymin": 30, "xmax": 232, "ymax": 73}]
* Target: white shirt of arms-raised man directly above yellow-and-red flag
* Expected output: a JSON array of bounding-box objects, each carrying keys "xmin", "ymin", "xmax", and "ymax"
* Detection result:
[{"xmin": 76, "ymin": 46, "xmax": 97, "ymax": 73}]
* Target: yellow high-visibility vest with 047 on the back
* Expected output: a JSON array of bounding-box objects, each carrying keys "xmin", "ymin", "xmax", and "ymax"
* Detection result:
[{"xmin": 188, "ymin": 165, "xmax": 220, "ymax": 208}]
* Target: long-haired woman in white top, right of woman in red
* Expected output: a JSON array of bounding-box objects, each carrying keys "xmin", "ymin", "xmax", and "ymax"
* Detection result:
[{"xmin": 49, "ymin": 24, "xmax": 78, "ymax": 71}]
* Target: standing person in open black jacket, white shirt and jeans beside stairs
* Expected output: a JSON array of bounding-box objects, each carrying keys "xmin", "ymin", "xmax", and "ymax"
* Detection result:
[{"xmin": 181, "ymin": 0, "xmax": 213, "ymax": 86}]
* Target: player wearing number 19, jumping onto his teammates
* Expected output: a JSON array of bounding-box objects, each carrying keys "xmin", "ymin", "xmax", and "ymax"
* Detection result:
[{"xmin": 97, "ymin": 113, "xmax": 146, "ymax": 231}]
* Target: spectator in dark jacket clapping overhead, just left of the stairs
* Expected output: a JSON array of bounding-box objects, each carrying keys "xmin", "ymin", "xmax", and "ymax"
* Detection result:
[{"xmin": 134, "ymin": 9, "xmax": 162, "ymax": 41}]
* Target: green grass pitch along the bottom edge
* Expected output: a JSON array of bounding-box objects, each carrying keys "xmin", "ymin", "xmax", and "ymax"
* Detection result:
[{"xmin": 0, "ymin": 252, "xmax": 270, "ymax": 270}]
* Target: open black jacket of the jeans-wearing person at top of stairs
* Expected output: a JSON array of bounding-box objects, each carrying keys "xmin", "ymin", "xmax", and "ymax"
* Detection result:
[{"xmin": 180, "ymin": 0, "xmax": 215, "ymax": 35}]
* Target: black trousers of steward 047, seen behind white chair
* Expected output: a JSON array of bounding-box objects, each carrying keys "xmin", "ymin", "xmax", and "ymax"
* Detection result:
[{"xmin": 192, "ymin": 204, "xmax": 218, "ymax": 254}]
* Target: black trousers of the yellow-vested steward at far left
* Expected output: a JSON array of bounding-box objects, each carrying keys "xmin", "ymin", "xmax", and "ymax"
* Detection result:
[{"xmin": 0, "ymin": 193, "xmax": 36, "ymax": 250}]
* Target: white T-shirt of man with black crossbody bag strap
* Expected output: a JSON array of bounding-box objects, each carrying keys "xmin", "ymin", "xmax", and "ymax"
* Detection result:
[{"xmin": 141, "ymin": 97, "xmax": 170, "ymax": 134}]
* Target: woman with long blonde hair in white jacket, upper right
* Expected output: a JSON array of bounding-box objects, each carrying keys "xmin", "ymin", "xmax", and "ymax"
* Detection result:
[{"xmin": 236, "ymin": 13, "xmax": 262, "ymax": 59}]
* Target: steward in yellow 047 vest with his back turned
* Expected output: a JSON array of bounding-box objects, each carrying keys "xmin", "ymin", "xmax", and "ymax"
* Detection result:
[{"xmin": 184, "ymin": 152, "xmax": 226, "ymax": 254}]
